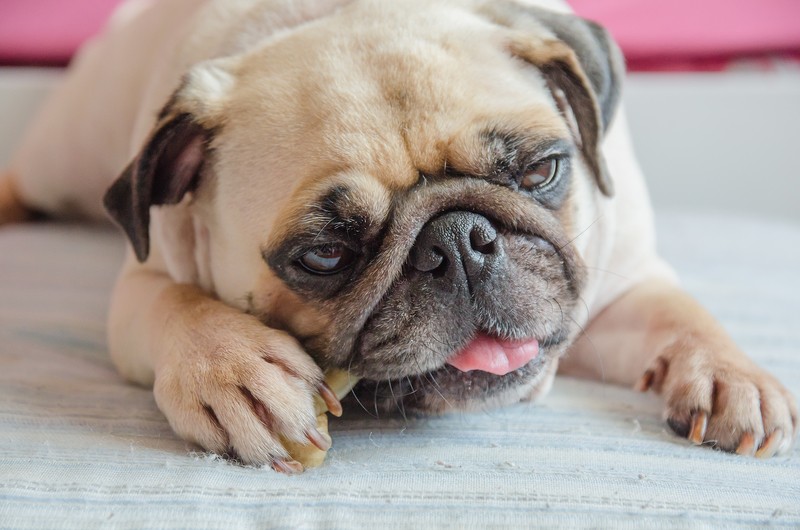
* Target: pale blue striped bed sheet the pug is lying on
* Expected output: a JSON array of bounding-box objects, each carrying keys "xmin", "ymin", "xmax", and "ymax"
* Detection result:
[{"xmin": 0, "ymin": 213, "xmax": 800, "ymax": 528}]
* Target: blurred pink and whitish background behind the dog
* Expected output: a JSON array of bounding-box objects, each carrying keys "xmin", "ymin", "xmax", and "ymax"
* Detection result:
[{"xmin": 0, "ymin": 0, "xmax": 800, "ymax": 222}]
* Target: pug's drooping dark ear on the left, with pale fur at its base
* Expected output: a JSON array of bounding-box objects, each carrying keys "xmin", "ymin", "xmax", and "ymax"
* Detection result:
[{"xmin": 103, "ymin": 60, "xmax": 230, "ymax": 262}]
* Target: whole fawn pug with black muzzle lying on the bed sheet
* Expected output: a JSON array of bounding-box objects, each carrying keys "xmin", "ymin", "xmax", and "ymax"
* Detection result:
[{"xmin": 0, "ymin": 0, "xmax": 798, "ymax": 473}]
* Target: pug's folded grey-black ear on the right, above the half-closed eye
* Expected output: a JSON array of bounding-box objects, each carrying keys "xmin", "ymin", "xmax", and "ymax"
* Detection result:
[{"xmin": 483, "ymin": 2, "xmax": 625, "ymax": 196}]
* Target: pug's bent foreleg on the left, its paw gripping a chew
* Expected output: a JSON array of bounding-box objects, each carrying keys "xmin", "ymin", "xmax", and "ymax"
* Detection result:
[{"xmin": 109, "ymin": 260, "xmax": 340, "ymax": 472}]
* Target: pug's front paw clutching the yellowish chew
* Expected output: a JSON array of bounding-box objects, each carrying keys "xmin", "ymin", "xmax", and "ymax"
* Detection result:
[{"xmin": 153, "ymin": 315, "xmax": 341, "ymax": 473}]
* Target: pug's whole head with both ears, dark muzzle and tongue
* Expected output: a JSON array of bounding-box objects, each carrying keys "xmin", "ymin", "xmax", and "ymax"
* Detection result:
[{"xmin": 106, "ymin": 2, "xmax": 620, "ymax": 412}]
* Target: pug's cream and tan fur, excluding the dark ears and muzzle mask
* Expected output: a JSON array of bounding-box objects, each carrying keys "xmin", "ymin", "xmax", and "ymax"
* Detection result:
[{"xmin": 0, "ymin": 0, "xmax": 797, "ymax": 467}]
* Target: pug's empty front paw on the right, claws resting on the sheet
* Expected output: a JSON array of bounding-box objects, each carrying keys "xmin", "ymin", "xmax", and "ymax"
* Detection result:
[{"xmin": 637, "ymin": 338, "xmax": 798, "ymax": 457}]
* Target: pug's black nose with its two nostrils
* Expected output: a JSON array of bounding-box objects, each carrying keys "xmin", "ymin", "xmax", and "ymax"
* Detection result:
[{"xmin": 410, "ymin": 212, "xmax": 499, "ymax": 284}]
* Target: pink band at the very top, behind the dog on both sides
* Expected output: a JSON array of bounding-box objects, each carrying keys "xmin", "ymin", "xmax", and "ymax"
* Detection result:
[{"xmin": 0, "ymin": 0, "xmax": 800, "ymax": 70}]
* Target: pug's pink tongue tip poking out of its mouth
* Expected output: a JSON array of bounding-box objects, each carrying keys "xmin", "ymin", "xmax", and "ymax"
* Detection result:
[{"xmin": 447, "ymin": 334, "xmax": 539, "ymax": 375}]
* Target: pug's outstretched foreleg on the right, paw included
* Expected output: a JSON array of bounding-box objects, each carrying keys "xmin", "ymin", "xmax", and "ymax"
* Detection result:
[{"xmin": 561, "ymin": 281, "xmax": 798, "ymax": 456}]
